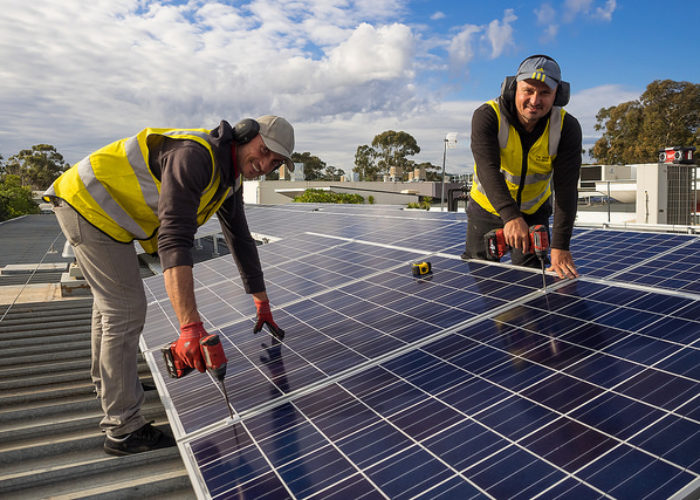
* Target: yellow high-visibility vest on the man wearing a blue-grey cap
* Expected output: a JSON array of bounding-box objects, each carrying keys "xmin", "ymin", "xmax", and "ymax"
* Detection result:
[{"xmin": 469, "ymin": 100, "xmax": 566, "ymax": 215}]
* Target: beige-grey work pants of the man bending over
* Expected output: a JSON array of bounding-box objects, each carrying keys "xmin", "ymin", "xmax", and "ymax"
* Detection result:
[{"xmin": 54, "ymin": 203, "xmax": 146, "ymax": 436}]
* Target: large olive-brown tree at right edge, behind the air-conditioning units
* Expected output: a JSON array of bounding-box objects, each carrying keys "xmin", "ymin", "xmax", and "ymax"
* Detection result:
[{"xmin": 589, "ymin": 80, "xmax": 700, "ymax": 164}]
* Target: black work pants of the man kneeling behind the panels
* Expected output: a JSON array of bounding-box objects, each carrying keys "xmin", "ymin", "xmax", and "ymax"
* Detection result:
[{"xmin": 462, "ymin": 200, "xmax": 552, "ymax": 269}]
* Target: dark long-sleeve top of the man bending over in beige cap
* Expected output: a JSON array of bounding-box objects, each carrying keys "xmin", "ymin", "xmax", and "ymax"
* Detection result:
[{"xmin": 149, "ymin": 121, "xmax": 265, "ymax": 293}]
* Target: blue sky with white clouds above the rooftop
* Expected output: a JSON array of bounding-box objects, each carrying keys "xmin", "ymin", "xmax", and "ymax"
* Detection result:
[{"xmin": 0, "ymin": 0, "xmax": 700, "ymax": 174}]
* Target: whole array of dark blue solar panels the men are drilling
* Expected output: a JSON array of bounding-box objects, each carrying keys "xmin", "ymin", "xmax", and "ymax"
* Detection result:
[{"xmin": 142, "ymin": 206, "xmax": 700, "ymax": 499}]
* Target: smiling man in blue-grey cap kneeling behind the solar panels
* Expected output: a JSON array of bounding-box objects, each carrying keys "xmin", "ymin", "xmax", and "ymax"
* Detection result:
[{"xmin": 462, "ymin": 55, "xmax": 582, "ymax": 278}]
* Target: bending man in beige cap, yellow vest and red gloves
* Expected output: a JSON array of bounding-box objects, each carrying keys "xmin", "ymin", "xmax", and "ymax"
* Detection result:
[{"xmin": 44, "ymin": 115, "xmax": 294, "ymax": 455}]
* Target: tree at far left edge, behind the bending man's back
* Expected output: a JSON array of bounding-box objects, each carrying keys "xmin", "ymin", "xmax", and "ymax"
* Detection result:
[{"xmin": 4, "ymin": 144, "xmax": 68, "ymax": 189}]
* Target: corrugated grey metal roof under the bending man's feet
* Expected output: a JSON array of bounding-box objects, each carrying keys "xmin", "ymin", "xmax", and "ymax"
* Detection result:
[{"xmin": 0, "ymin": 214, "xmax": 195, "ymax": 499}]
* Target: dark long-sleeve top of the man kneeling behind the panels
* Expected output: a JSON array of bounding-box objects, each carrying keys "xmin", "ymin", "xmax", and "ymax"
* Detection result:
[{"xmin": 471, "ymin": 97, "xmax": 582, "ymax": 250}]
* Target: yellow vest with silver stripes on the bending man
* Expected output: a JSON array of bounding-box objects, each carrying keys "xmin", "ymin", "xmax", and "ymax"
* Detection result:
[{"xmin": 43, "ymin": 128, "xmax": 241, "ymax": 253}]
